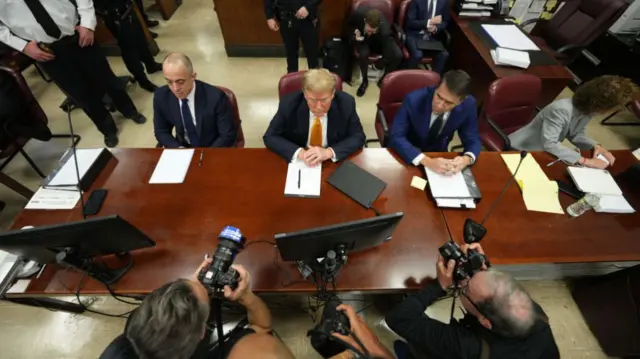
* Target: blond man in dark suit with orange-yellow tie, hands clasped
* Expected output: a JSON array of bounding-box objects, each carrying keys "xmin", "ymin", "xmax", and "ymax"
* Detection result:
[{"xmin": 263, "ymin": 69, "xmax": 365, "ymax": 166}]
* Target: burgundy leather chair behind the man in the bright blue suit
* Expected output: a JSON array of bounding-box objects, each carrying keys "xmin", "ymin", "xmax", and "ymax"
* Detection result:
[{"xmin": 365, "ymin": 70, "xmax": 440, "ymax": 147}]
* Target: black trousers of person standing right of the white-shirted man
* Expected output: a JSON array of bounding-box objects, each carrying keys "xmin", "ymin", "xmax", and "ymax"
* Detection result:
[{"xmin": 104, "ymin": 10, "xmax": 156, "ymax": 80}]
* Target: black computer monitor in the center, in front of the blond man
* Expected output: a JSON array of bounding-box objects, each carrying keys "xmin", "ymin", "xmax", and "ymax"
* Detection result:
[{"xmin": 275, "ymin": 212, "xmax": 404, "ymax": 261}]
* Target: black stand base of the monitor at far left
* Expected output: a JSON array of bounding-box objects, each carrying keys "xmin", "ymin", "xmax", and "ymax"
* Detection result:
[{"xmin": 56, "ymin": 248, "xmax": 133, "ymax": 285}]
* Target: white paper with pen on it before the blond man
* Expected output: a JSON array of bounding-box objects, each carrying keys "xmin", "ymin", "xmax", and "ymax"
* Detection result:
[{"xmin": 284, "ymin": 161, "xmax": 322, "ymax": 198}]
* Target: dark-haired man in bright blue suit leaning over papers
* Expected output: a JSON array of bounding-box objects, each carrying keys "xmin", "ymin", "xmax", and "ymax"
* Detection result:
[{"xmin": 389, "ymin": 70, "xmax": 480, "ymax": 175}]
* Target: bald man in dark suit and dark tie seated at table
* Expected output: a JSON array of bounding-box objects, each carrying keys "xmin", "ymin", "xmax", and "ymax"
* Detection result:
[{"xmin": 153, "ymin": 53, "xmax": 237, "ymax": 148}]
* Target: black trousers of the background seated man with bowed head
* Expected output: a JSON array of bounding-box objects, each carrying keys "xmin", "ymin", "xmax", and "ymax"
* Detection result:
[{"xmin": 356, "ymin": 38, "xmax": 402, "ymax": 81}]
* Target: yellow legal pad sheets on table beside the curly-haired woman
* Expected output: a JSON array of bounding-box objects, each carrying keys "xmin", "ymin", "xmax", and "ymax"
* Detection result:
[{"xmin": 502, "ymin": 153, "xmax": 564, "ymax": 214}]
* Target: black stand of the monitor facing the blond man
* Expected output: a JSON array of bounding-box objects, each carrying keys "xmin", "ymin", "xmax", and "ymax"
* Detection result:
[{"xmin": 296, "ymin": 245, "xmax": 347, "ymax": 285}]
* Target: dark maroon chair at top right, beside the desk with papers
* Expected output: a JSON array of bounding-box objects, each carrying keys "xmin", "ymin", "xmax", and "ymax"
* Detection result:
[{"xmin": 520, "ymin": 0, "xmax": 627, "ymax": 65}]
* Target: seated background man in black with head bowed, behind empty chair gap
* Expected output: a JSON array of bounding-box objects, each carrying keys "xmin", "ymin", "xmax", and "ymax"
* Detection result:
[{"xmin": 347, "ymin": 6, "xmax": 402, "ymax": 96}]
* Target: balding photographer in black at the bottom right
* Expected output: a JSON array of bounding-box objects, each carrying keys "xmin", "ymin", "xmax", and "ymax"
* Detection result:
[{"xmin": 386, "ymin": 243, "xmax": 560, "ymax": 359}]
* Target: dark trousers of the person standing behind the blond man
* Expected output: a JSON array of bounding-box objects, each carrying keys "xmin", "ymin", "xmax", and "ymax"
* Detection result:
[{"xmin": 279, "ymin": 13, "xmax": 320, "ymax": 73}]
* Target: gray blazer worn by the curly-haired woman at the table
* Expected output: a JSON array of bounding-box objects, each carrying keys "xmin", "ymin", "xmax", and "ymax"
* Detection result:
[{"xmin": 509, "ymin": 99, "xmax": 597, "ymax": 164}]
